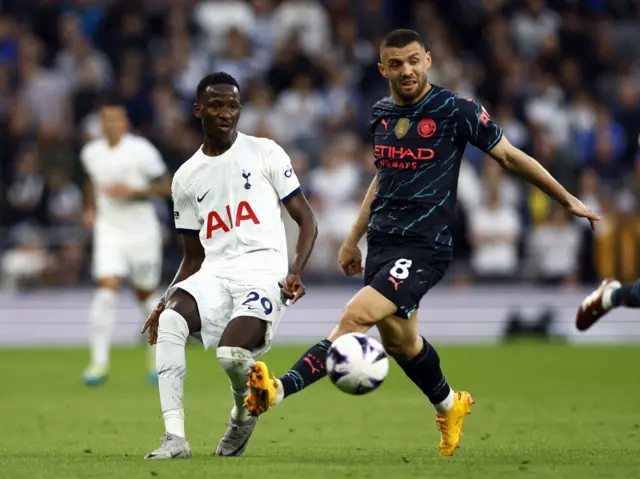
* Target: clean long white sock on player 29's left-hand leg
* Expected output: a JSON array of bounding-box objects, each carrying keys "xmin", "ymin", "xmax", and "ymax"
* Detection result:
[{"xmin": 156, "ymin": 309, "xmax": 189, "ymax": 437}]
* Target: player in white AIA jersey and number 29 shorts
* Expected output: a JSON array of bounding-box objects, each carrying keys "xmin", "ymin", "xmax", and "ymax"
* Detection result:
[{"xmin": 142, "ymin": 72, "xmax": 317, "ymax": 459}]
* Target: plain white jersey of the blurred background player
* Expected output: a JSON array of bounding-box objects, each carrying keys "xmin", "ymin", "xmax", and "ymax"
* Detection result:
[{"xmin": 80, "ymin": 134, "xmax": 167, "ymax": 237}]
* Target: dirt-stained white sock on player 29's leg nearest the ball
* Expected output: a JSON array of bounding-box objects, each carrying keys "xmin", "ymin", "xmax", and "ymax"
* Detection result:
[{"xmin": 216, "ymin": 346, "xmax": 255, "ymax": 421}]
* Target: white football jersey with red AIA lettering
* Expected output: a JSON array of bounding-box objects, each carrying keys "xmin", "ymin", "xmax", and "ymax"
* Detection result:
[{"xmin": 172, "ymin": 133, "xmax": 300, "ymax": 282}]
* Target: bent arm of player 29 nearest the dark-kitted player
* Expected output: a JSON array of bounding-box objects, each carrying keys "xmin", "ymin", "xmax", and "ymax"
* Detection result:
[{"xmin": 283, "ymin": 192, "xmax": 318, "ymax": 304}]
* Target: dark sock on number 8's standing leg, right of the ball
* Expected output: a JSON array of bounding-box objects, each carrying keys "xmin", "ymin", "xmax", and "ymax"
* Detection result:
[{"xmin": 398, "ymin": 338, "xmax": 451, "ymax": 409}]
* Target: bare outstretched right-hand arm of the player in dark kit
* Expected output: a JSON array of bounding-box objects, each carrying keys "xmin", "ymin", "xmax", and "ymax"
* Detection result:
[{"xmin": 489, "ymin": 136, "xmax": 600, "ymax": 228}]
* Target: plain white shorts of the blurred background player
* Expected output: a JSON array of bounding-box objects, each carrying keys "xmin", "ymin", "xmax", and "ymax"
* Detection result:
[{"xmin": 93, "ymin": 235, "xmax": 162, "ymax": 291}]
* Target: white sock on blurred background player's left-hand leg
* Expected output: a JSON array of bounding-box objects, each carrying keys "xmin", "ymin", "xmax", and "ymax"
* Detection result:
[{"xmin": 89, "ymin": 288, "xmax": 117, "ymax": 368}]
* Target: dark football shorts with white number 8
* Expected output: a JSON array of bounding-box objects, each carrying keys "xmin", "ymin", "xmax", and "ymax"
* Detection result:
[{"xmin": 364, "ymin": 236, "xmax": 451, "ymax": 318}]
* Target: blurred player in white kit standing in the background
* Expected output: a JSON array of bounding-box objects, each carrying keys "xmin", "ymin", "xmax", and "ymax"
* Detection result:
[{"xmin": 80, "ymin": 96, "xmax": 171, "ymax": 385}]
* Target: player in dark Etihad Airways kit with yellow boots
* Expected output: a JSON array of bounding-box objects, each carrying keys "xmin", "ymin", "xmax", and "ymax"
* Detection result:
[{"xmin": 246, "ymin": 30, "xmax": 599, "ymax": 456}]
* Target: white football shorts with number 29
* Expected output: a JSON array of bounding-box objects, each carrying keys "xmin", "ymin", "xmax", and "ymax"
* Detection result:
[{"xmin": 174, "ymin": 270, "xmax": 285, "ymax": 357}]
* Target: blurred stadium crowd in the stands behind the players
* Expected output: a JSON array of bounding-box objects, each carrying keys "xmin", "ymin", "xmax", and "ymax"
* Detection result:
[{"xmin": 0, "ymin": 0, "xmax": 640, "ymax": 287}]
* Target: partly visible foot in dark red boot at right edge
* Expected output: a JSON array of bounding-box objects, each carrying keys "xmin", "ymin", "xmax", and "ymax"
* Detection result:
[{"xmin": 576, "ymin": 279, "xmax": 640, "ymax": 331}]
